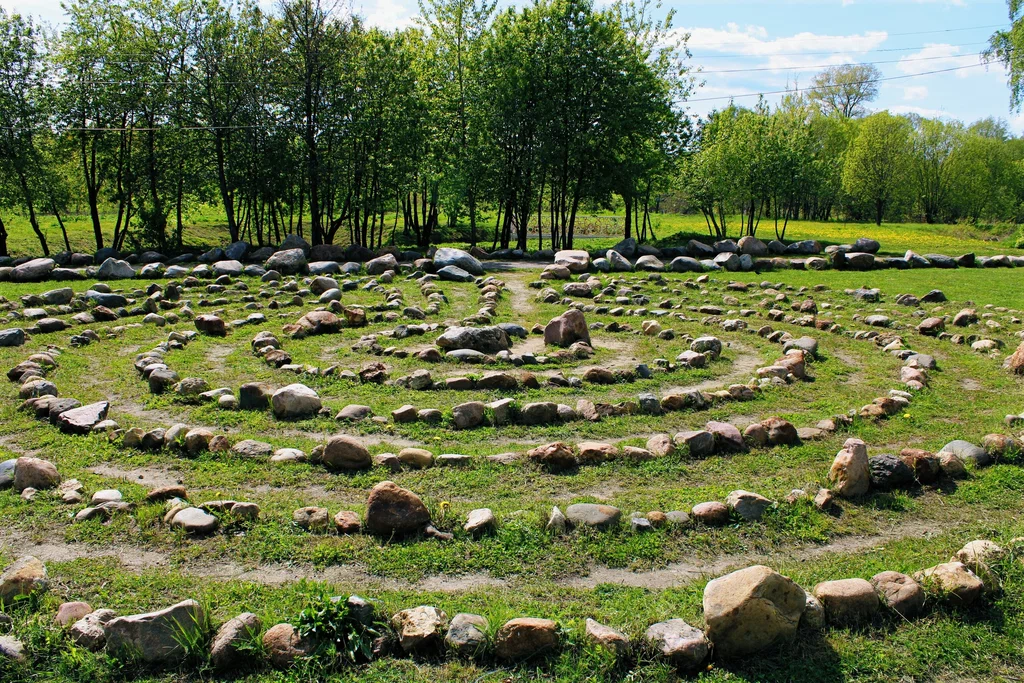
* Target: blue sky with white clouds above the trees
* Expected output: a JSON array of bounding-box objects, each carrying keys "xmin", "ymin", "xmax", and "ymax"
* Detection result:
[{"xmin": 0, "ymin": 0, "xmax": 1024, "ymax": 134}]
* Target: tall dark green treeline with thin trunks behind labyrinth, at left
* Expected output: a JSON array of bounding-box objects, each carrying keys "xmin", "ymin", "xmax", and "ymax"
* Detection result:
[{"xmin": 0, "ymin": 0, "xmax": 690, "ymax": 253}]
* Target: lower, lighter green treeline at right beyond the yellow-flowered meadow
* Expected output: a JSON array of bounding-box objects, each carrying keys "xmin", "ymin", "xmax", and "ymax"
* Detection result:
[{"xmin": 676, "ymin": 100, "xmax": 1024, "ymax": 239}]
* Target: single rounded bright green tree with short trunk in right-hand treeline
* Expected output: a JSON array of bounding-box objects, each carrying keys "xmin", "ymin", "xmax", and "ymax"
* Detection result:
[{"xmin": 843, "ymin": 112, "xmax": 911, "ymax": 225}]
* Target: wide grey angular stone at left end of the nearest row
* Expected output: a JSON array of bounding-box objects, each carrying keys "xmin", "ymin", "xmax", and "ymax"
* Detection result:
[{"xmin": 105, "ymin": 600, "xmax": 205, "ymax": 665}]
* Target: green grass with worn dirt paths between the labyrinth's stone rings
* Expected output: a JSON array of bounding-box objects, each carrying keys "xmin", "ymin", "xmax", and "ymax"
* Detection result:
[{"xmin": 0, "ymin": 260, "xmax": 1024, "ymax": 683}]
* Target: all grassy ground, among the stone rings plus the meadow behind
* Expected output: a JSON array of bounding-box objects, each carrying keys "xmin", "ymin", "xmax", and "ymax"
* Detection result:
[{"xmin": 0, "ymin": 232, "xmax": 1024, "ymax": 683}]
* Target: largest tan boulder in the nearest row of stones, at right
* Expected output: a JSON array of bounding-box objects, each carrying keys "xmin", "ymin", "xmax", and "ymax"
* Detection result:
[{"xmin": 703, "ymin": 565, "xmax": 807, "ymax": 657}]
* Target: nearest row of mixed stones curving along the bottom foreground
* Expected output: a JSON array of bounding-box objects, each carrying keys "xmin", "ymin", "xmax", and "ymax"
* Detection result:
[{"xmin": 0, "ymin": 540, "xmax": 1007, "ymax": 674}]
